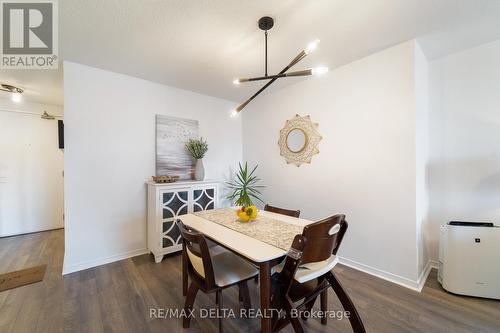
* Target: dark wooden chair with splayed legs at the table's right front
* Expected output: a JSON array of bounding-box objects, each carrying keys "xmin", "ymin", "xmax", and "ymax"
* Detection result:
[{"xmin": 271, "ymin": 214, "xmax": 366, "ymax": 333}]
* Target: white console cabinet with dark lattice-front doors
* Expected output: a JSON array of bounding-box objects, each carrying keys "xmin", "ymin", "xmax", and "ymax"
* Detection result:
[{"xmin": 147, "ymin": 181, "xmax": 219, "ymax": 263}]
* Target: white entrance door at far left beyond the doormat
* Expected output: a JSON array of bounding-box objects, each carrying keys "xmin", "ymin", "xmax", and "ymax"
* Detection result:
[{"xmin": 0, "ymin": 99, "xmax": 63, "ymax": 237}]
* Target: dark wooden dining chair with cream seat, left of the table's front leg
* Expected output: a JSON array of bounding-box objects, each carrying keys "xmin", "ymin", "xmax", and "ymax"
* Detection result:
[{"xmin": 176, "ymin": 220, "xmax": 258, "ymax": 332}]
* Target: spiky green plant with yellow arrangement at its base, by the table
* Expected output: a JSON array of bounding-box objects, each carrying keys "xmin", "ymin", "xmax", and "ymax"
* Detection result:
[{"xmin": 227, "ymin": 162, "xmax": 265, "ymax": 222}]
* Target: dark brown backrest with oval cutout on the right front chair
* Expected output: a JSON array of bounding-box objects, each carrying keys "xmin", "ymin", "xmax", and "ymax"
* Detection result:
[{"xmin": 302, "ymin": 214, "xmax": 347, "ymax": 264}]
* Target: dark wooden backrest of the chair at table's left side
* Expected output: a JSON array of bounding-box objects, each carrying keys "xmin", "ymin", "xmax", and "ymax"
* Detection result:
[{"xmin": 176, "ymin": 220, "xmax": 215, "ymax": 290}]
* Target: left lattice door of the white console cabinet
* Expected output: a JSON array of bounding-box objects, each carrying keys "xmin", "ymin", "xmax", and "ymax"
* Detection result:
[{"xmin": 160, "ymin": 189, "xmax": 189, "ymax": 252}]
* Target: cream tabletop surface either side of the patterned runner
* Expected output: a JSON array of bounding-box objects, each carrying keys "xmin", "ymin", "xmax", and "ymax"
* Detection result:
[{"xmin": 179, "ymin": 211, "xmax": 313, "ymax": 262}]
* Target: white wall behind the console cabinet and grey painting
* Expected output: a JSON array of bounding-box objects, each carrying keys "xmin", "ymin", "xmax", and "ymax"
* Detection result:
[{"xmin": 64, "ymin": 62, "xmax": 242, "ymax": 273}]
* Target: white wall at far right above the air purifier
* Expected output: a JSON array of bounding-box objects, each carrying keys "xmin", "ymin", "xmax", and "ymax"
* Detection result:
[{"xmin": 427, "ymin": 40, "xmax": 500, "ymax": 259}]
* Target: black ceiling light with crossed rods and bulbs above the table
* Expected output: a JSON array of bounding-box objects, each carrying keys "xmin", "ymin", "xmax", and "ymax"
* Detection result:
[{"xmin": 232, "ymin": 16, "xmax": 328, "ymax": 116}]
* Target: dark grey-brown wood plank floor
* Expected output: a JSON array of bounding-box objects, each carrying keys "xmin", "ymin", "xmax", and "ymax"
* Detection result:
[{"xmin": 0, "ymin": 230, "xmax": 500, "ymax": 333}]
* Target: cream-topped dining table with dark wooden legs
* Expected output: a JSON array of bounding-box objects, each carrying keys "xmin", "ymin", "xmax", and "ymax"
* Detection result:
[{"xmin": 179, "ymin": 208, "xmax": 313, "ymax": 333}]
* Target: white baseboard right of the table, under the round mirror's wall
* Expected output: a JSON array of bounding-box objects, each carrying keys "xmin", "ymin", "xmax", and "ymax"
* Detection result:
[{"xmin": 339, "ymin": 257, "xmax": 437, "ymax": 292}]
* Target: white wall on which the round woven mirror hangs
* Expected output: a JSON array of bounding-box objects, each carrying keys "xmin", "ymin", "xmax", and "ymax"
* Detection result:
[{"xmin": 242, "ymin": 41, "xmax": 426, "ymax": 287}]
